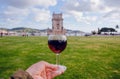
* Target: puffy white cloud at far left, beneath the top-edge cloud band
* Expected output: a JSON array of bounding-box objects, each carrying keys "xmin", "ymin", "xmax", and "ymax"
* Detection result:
[{"xmin": 1, "ymin": 6, "xmax": 29, "ymax": 24}]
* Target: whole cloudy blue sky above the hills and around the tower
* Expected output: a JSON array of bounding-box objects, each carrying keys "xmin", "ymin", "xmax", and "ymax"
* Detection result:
[{"xmin": 0, "ymin": 0, "xmax": 120, "ymax": 32}]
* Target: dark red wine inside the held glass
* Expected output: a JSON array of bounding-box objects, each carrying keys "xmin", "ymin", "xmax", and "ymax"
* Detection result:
[{"xmin": 48, "ymin": 40, "xmax": 67, "ymax": 54}]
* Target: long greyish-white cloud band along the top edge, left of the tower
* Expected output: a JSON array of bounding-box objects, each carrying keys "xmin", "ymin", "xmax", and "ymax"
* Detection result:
[{"xmin": 0, "ymin": 0, "xmax": 57, "ymax": 8}]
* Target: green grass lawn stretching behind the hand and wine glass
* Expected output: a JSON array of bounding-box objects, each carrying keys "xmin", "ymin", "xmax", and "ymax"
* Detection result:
[{"xmin": 0, "ymin": 36, "xmax": 120, "ymax": 79}]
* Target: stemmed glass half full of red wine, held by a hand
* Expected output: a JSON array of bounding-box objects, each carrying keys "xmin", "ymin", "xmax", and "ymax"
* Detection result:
[{"xmin": 48, "ymin": 34, "xmax": 67, "ymax": 69}]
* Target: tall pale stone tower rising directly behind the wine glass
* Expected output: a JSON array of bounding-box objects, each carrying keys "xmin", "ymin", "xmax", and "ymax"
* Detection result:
[{"xmin": 47, "ymin": 13, "xmax": 66, "ymax": 35}]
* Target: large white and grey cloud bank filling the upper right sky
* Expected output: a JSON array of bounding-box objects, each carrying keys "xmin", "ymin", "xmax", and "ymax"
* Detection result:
[{"xmin": 62, "ymin": 0, "xmax": 120, "ymax": 24}]
